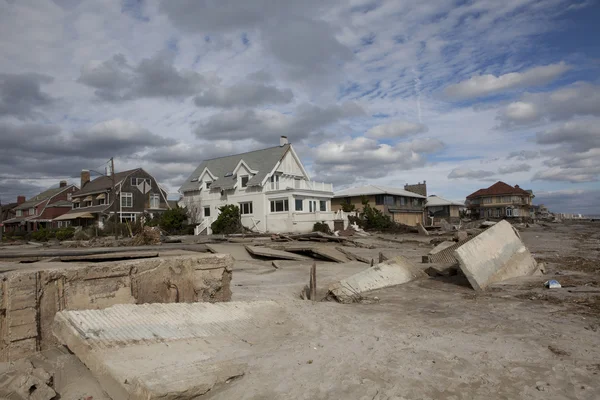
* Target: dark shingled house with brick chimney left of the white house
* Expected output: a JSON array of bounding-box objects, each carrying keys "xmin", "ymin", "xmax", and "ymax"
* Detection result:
[{"xmin": 55, "ymin": 168, "xmax": 171, "ymax": 228}]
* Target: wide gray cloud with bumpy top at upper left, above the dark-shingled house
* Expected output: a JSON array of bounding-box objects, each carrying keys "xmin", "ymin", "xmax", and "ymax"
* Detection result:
[{"xmin": 78, "ymin": 53, "xmax": 212, "ymax": 102}]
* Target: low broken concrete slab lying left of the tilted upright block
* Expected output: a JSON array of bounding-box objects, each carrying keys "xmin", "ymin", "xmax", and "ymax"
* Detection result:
[{"xmin": 329, "ymin": 256, "xmax": 425, "ymax": 303}]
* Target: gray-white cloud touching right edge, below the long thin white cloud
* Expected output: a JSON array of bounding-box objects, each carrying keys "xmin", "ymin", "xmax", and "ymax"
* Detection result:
[{"xmin": 497, "ymin": 82, "xmax": 600, "ymax": 128}]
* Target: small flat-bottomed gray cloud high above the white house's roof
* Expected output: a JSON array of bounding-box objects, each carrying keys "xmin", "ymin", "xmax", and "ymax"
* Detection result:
[{"xmin": 194, "ymin": 82, "xmax": 294, "ymax": 108}]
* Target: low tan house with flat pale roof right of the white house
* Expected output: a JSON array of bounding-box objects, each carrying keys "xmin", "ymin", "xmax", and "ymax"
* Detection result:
[{"xmin": 331, "ymin": 183, "xmax": 427, "ymax": 226}]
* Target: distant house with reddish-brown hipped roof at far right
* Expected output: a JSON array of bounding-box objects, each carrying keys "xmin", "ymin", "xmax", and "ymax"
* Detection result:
[{"xmin": 466, "ymin": 181, "xmax": 535, "ymax": 218}]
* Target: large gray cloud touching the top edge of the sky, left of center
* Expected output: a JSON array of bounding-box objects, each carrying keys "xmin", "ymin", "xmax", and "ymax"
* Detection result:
[{"xmin": 160, "ymin": 0, "xmax": 353, "ymax": 78}]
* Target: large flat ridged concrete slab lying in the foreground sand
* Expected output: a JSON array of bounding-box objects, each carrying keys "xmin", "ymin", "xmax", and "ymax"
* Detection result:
[{"xmin": 53, "ymin": 301, "xmax": 281, "ymax": 400}]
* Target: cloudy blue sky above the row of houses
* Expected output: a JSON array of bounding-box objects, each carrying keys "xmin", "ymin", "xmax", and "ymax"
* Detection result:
[{"xmin": 0, "ymin": 0, "xmax": 600, "ymax": 214}]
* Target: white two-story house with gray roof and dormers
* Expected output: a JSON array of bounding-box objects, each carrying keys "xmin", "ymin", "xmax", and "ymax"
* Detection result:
[{"xmin": 179, "ymin": 136, "xmax": 344, "ymax": 234}]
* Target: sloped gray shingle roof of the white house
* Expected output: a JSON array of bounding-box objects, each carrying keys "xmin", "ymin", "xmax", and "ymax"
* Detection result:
[{"xmin": 179, "ymin": 144, "xmax": 290, "ymax": 192}]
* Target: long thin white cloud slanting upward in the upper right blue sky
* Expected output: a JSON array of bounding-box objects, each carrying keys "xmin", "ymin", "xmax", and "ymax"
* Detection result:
[{"xmin": 445, "ymin": 62, "xmax": 570, "ymax": 99}]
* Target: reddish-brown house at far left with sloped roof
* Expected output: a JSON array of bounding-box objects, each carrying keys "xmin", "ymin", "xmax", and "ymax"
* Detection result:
[{"xmin": 4, "ymin": 181, "xmax": 78, "ymax": 232}]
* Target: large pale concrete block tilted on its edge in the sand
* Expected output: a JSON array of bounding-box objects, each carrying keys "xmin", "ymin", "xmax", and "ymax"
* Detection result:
[{"xmin": 454, "ymin": 221, "xmax": 537, "ymax": 290}]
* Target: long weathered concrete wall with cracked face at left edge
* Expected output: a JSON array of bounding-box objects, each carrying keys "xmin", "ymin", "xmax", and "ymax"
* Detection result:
[{"xmin": 0, "ymin": 254, "xmax": 233, "ymax": 361}]
